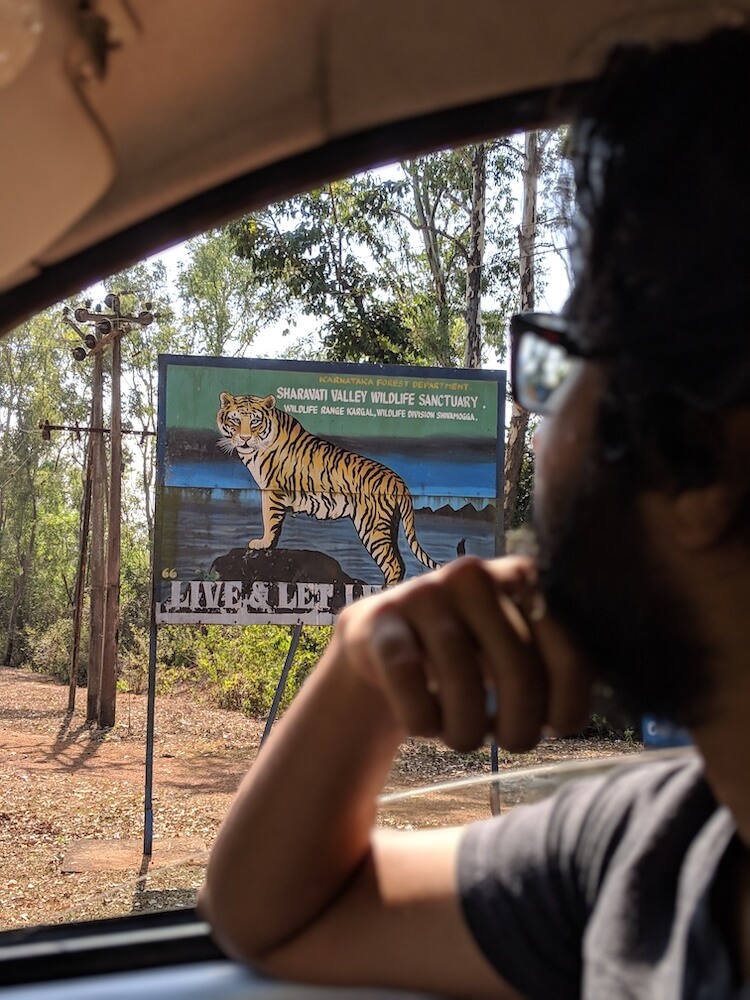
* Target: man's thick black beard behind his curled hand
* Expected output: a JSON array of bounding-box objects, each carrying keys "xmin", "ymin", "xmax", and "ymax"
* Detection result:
[{"xmin": 537, "ymin": 438, "xmax": 710, "ymax": 725}]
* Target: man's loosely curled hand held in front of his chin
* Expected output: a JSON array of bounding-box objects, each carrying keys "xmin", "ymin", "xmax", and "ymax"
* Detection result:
[{"xmin": 332, "ymin": 557, "xmax": 590, "ymax": 751}]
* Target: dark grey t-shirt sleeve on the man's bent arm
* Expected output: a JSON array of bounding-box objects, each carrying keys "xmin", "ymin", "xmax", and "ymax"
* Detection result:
[{"xmin": 458, "ymin": 764, "xmax": 648, "ymax": 1000}]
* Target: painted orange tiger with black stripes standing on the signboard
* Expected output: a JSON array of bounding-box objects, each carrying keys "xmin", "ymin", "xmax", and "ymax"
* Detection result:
[{"xmin": 216, "ymin": 392, "xmax": 438, "ymax": 587}]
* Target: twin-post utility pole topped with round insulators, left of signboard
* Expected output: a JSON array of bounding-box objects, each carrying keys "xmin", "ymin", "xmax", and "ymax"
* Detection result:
[{"xmin": 67, "ymin": 293, "xmax": 154, "ymax": 729}]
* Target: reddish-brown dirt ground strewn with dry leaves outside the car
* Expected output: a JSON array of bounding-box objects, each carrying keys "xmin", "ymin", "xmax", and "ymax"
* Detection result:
[{"xmin": 0, "ymin": 667, "xmax": 640, "ymax": 930}]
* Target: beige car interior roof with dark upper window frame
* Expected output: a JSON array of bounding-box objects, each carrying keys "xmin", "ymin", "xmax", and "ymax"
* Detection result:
[{"xmin": 0, "ymin": 0, "xmax": 750, "ymax": 333}]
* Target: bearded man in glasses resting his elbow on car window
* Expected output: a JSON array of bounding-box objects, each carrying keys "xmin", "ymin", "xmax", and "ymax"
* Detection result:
[{"xmin": 200, "ymin": 31, "xmax": 750, "ymax": 1000}]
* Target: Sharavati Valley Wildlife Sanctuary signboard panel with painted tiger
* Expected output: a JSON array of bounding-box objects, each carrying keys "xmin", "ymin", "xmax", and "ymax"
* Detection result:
[{"xmin": 154, "ymin": 355, "xmax": 505, "ymax": 624}]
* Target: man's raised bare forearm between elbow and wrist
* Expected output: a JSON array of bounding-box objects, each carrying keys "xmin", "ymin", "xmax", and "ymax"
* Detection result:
[{"xmin": 200, "ymin": 637, "xmax": 403, "ymax": 959}]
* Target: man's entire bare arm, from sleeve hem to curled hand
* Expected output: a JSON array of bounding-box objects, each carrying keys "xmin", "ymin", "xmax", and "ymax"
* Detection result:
[{"xmin": 200, "ymin": 558, "xmax": 589, "ymax": 997}]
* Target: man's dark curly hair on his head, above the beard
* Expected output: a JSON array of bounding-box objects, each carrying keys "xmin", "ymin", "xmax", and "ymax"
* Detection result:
[{"xmin": 566, "ymin": 29, "xmax": 750, "ymax": 486}]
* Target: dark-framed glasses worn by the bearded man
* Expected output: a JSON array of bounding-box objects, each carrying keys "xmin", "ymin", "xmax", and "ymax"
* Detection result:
[{"xmin": 510, "ymin": 312, "xmax": 611, "ymax": 416}]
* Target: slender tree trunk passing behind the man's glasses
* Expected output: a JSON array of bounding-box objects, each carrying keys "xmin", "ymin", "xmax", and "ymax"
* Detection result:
[{"xmin": 503, "ymin": 132, "xmax": 540, "ymax": 532}]
